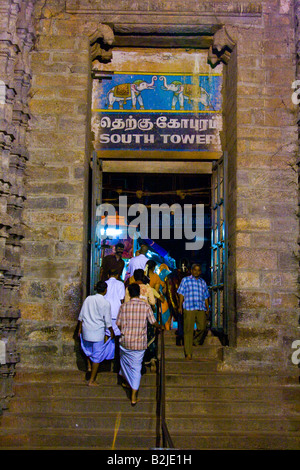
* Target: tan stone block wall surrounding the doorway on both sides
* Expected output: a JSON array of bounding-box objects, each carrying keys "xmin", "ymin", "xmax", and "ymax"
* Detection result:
[{"xmin": 15, "ymin": 0, "xmax": 298, "ymax": 374}]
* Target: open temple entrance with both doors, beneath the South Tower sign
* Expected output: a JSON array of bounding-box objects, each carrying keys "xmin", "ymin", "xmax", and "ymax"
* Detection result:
[{"xmin": 90, "ymin": 154, "xmax": 227, "ymax": 336}]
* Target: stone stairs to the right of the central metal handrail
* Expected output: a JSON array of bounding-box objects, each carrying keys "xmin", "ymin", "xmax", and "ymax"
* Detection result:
[{"xmin": 165, "ymin": 331, "xmax": 300, "ymax": 450}]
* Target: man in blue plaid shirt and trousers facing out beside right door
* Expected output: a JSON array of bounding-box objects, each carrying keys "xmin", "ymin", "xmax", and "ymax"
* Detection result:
[{"xmin": 177, "ymin": 263, "xmax": 209, "ymax": 360}]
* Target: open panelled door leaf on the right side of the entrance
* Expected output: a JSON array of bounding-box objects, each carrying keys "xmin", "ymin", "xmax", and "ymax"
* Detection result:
[{"xmin": 211, "ymin": 152, "xmax": 228, "ymax": 335}]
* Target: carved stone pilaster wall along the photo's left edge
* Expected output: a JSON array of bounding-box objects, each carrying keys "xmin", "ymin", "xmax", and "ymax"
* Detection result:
[{"xmin": 0, "ymin": 0, "xmax": 35, "ymax": 412}]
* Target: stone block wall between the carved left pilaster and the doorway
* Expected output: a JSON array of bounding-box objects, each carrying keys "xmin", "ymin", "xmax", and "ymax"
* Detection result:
[{"xmin": 19, "ymin": 1, "xmax": 90, "ymax": 367}]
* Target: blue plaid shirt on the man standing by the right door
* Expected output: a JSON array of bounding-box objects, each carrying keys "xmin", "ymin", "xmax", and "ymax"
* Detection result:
[{"xmin": 177, "ymin": 276, "xmax": 209, "ymax": 310}]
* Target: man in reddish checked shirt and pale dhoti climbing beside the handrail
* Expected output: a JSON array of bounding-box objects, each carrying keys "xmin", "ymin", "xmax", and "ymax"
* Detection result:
[{"xmin": 116, "ymin": 284, "xmax": 162, "ymax": 406}]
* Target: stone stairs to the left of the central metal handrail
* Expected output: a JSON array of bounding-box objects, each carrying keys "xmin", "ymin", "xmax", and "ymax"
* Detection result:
[{"xmin": 0, "ymin": 370, "xmax": 156, "ymax": 450}]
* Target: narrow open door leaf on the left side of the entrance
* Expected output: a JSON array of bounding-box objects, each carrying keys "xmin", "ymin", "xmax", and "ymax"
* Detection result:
[{"xmin": 90, "ymin": 152, "xmax": 102, "ymax": 294}]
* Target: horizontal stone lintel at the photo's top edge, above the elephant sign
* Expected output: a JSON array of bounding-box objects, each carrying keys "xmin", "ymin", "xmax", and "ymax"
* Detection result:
[{"xmin": 66, "ymin": 0, "xmax": 262, "ymax": 40}]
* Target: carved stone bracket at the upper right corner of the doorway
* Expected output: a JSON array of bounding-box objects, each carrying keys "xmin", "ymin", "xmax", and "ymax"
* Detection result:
[{"xmin": 208, "ymin": 26, "xmax": 236, "ymax": 67}]
